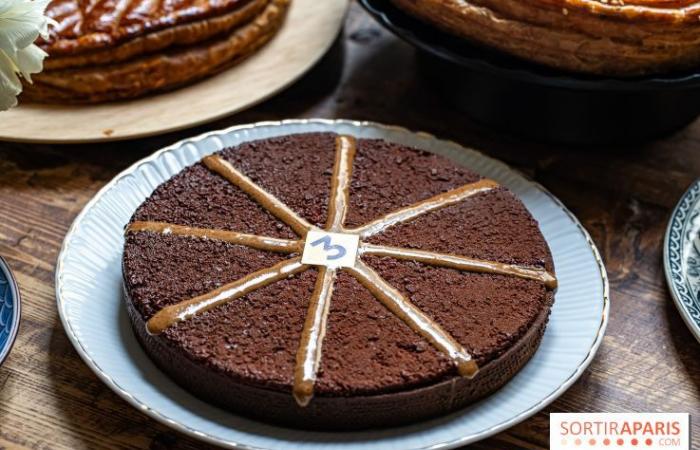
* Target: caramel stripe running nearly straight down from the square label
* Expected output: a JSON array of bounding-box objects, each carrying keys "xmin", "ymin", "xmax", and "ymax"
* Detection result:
[{"xmin": 292, "ymin": 267, "xmax": 336, "ymax": 407}]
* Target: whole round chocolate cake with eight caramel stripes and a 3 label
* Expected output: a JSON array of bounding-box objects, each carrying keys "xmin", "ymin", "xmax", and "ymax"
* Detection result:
[{"xmin": 123, "ymin": 133, "xmax": 556, "ymax": 430}]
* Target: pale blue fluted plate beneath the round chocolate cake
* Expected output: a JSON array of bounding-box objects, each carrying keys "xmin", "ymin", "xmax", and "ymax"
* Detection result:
[{"xmin": 56, "ymin": 120, "xmax": 609, "ymax": 450}]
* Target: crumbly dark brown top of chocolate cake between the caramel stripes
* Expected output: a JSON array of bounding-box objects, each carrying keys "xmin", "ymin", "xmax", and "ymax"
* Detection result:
[{"xmin": 123, "ymin": 133, "xmax": 553, "ymax": 428}]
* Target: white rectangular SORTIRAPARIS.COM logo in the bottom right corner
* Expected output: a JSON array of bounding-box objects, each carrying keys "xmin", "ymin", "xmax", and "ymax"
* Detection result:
[{"xmin": 549, "ymin": 413, "xmax": 690, "ymax": 450}]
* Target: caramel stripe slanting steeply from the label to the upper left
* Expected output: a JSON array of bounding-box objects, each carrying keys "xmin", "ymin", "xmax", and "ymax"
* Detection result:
[{"xmin": 202, "ymin": 155, "xmax": 313, "ymax": 237}]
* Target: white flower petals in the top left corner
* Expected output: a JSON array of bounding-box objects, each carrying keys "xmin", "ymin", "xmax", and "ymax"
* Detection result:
[{"xmin": 0, "ymin": 0, "xmax": 55, "ymax": 111}]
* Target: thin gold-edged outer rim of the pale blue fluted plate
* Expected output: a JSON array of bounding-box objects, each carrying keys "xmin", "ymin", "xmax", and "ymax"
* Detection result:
[{"xmin": 55, "ymin": 118, "xmax": 610, "ymax": 450}]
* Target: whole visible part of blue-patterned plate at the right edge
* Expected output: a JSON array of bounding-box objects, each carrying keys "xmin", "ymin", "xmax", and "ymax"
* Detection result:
[{"xmin": 664, "ymin": 180, "xmax": 700, "ymax": 341}]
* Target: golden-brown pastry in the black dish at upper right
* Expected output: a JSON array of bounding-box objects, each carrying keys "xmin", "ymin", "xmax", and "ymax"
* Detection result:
[{"xmin": 392, "ymin": 0, "xmax": 700, "ymax": 76}]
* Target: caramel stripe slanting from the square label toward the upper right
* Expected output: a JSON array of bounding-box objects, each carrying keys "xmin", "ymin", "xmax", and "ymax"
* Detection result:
[{"xmin": 346, "ymin": 179, "xmax": 498, "ymax": 238}]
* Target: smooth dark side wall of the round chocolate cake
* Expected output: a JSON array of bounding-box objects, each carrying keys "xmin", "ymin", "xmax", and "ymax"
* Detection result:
[{"xmin": 122, "ymin": 274, "xmax": 554, "ymax": 431}]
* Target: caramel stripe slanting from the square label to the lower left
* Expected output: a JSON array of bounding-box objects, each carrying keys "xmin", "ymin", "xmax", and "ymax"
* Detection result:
[{"xmin": 146, "ymin": 257, "xmax": 309, "ymax": 334}]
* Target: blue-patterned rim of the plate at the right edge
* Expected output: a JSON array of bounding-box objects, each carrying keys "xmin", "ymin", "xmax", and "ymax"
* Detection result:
[{"xmin": 663, "ymin": 179, "xmax": 700, "ymax": 342}]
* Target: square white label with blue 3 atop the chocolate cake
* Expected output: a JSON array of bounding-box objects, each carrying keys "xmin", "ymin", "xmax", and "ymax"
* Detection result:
[{"xmin": 301, "ymin": 230, "xmax": 360, "ymax": 268}]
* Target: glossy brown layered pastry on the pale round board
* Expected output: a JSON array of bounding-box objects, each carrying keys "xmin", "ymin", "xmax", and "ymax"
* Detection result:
[{"xmin": 23, "ymin": 0, "xmax": 291, "ymax": 103}]
